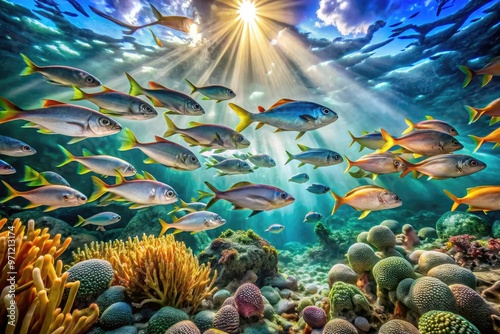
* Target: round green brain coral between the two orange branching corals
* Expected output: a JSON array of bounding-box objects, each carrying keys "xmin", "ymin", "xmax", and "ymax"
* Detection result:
[{"xmin": 68, "ymin": 259, "xmax": 114, "ymax": 301}]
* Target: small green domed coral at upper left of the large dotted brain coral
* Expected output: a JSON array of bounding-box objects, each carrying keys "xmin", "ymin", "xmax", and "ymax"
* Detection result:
[{"xmin": 372, "ymin": 257, "xmax": 415, "ymax": 291}]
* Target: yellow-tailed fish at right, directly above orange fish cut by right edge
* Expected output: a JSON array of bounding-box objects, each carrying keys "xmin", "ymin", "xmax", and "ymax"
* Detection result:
[{"xmin": 400, "ymin": 154, "xmax": 486, "ymax": 180}]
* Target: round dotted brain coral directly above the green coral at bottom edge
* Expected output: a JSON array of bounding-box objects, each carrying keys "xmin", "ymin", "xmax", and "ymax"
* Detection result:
[{"xmin": 406, "ymin": 277, "xmax": 457, "ymax": 314}]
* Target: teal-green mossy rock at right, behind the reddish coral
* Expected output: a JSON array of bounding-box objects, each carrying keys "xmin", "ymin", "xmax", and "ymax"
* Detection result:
[{"xmin": 436, "ymin": 212, "xmax": 491, "ymax": 239}]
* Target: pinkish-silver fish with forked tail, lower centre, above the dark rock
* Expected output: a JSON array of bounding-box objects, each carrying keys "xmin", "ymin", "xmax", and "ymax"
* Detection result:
[{"xmin": 201, "ymin": 182, "xmax": 295, "ymax": 218}]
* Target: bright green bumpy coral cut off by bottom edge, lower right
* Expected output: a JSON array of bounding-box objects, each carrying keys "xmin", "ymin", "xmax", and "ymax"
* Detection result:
[{"xmin": 418, "ymin": 311, "xmax": 481, "ymax": 334}]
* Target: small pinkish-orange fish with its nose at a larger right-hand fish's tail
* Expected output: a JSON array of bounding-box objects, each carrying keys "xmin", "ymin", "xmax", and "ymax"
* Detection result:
[{"xmin": 344, "ymin": 152, "xmax": 406, "ymax": 179}]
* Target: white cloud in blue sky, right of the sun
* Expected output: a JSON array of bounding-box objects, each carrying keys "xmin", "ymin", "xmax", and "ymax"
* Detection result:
[{"xmin": 316, "ymin": 0, "xmax": 399, "ymax": 35}]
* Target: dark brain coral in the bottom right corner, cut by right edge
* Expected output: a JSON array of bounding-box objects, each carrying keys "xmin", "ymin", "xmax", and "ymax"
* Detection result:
[{"xmin": 450, "ymin": 284, "xmax": 500, "ymax": 333}]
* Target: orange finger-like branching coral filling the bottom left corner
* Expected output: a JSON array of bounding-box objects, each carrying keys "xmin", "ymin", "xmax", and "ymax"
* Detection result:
[{"xmin": 0, "ymin": 219, "xmax": 99, "ymax": 334}]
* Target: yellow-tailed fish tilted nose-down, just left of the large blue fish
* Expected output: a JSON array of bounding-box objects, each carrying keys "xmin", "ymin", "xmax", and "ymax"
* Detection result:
[{"xmin": 125, "ymin": 73, "xmax": 205, "ymax": 116}]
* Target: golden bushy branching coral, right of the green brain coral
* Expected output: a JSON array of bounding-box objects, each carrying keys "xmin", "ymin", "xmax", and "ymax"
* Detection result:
[{"xmin": 73, "ymin": 235, "xmax": 217, "ymax": 313}]
